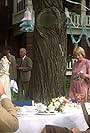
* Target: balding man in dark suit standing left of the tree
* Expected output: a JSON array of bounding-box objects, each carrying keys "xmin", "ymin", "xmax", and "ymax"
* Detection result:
[{"xmin": 17, "ymin": 48, "xmax": 32, "ymax": 99}]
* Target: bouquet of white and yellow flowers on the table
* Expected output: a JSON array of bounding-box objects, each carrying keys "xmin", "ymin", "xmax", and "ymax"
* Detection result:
[{"xmin": 48, "ymin": 96, "xmax": 69, "ymax": 112}]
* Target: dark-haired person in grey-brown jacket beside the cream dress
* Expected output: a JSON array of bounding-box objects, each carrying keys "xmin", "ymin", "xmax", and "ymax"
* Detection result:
[{"xmin": 4, "ymin": 46, "xmax": 17, "ymax": 81}]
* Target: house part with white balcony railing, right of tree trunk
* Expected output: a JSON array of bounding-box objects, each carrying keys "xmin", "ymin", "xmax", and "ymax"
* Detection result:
[{"xmin": 66, "ymin": 0, "xmax": 90, "ymax": 75}]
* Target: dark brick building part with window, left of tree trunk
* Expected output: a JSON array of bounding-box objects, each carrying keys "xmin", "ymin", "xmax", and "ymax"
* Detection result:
[{"xmin": 0, "ymin": 0, "xmax": 33, "ymax": 58}]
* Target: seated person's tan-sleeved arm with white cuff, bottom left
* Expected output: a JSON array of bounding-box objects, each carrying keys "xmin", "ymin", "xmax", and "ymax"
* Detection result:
[{"xmin": 0, "ymin": 82, "xmax": 19, "ymax": 133}]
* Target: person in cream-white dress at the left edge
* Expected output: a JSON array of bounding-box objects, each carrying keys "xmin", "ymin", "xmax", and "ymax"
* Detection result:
[{"xmin": 0, "ymin": 49, "xmax": 11, "ymax": 99}]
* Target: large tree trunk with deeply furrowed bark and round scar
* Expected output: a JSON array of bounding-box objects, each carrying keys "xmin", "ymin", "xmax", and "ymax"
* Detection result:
[{"xmin": 30, "ymin": 0, "xmax": 67, "ymax": 103}]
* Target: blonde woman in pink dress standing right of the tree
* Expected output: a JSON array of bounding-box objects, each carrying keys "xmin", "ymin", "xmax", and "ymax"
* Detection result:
[{"xmin": 69, "ymin": 47, "xmax": 90, "ymax": 101}]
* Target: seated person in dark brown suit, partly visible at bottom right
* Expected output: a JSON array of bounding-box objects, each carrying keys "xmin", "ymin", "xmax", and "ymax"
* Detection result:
[{"xmin": 41, "ymin": 103, "xmax": 90, "ymax": 133}]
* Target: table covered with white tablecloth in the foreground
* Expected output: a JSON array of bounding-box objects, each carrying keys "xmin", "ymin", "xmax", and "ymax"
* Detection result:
[{"xmin": 16, "ymin": 105, "xmax": 88, "ymax": 133}]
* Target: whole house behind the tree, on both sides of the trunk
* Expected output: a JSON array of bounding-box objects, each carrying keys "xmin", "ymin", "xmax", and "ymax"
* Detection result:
[{"xmin": 0, "ymin": 0, "xmax": 90, "ymax": 59}]
